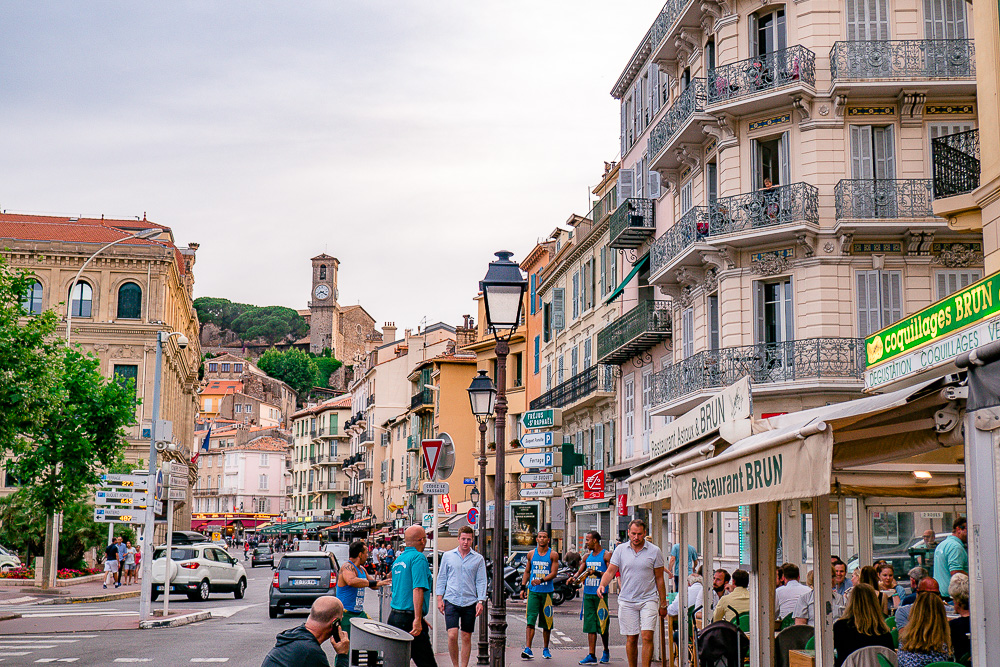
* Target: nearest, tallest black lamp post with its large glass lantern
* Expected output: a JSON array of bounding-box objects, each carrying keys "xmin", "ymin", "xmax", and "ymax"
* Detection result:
[{"xmin": 479, "ymin": 250, "xmax": 528, "ymax": 667}]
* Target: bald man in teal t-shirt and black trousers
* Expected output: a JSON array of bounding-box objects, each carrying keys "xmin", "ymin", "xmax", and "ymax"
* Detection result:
[{"xmin": 387, "ymin": 525, "xmax": 437, "ymax": 667}]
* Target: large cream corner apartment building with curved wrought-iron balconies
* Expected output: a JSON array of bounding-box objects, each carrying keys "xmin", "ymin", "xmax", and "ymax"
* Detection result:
[{"xmin": 598, "ymin": 0, "xmax": 983, "ymax": 568}]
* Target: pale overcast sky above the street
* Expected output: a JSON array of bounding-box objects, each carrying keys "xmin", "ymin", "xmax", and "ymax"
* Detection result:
[{"xmin": 0, "ymin": 0, "xmax": 662, "ymax": 329}]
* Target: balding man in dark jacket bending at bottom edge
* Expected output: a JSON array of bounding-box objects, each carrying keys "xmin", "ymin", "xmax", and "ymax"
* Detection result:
[{"xmin": 261, "ymin": 595, "xmax": 351, "ymax": 667}]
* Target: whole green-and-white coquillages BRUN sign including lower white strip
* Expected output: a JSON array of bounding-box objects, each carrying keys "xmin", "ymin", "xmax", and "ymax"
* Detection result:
[{"xmin": 865, "ymin": 273, "xmax": 1000, "ymax": 389}]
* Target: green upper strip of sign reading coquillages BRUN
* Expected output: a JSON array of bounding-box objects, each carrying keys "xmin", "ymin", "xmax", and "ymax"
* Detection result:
[{"xmin": 865, "ymin": 273, "xmax": 1000, "ymax": 368}]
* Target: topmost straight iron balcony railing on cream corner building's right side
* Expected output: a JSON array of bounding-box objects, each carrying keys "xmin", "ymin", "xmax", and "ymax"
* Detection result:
[{"xmin": 830, "ymin": 39, "xmax": 976, "ymax": 81}]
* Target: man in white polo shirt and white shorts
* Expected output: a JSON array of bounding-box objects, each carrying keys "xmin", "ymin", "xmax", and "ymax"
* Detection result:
[{"xmin": 597, "ymin": 519, "xmax": 667, "ymax": 667}]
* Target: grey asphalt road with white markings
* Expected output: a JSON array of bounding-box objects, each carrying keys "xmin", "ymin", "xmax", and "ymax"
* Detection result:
[{"xmin": 0, "ymin": 552, "xmax": 624, "ymax": 667}]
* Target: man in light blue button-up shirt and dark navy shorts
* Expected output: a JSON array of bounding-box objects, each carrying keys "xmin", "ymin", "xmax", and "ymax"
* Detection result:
[{"xmin": 438, "ymin": 526, "xmax": 486, "ymax": 667}]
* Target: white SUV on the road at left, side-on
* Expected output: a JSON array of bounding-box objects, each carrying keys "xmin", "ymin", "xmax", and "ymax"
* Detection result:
[{"xmin": 153, "ymin": 543, "xmax": 247, "ymax": 600}]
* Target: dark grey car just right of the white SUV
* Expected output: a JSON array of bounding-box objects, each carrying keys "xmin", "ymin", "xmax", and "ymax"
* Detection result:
[{"xmin": 267, "ymin": 551, "xmax": 339, "ymax": 618}]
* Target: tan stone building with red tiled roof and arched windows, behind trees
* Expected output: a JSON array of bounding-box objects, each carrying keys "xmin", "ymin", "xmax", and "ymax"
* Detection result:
[{"xmin": 0, "ymin": 213, "xmax": 201, "ymax": 527}]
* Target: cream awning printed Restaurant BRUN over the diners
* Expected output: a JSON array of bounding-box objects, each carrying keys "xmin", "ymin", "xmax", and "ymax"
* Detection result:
[{"xmin": 668, "ymin": 379, "xmax": 963, "ymax": 513}]
